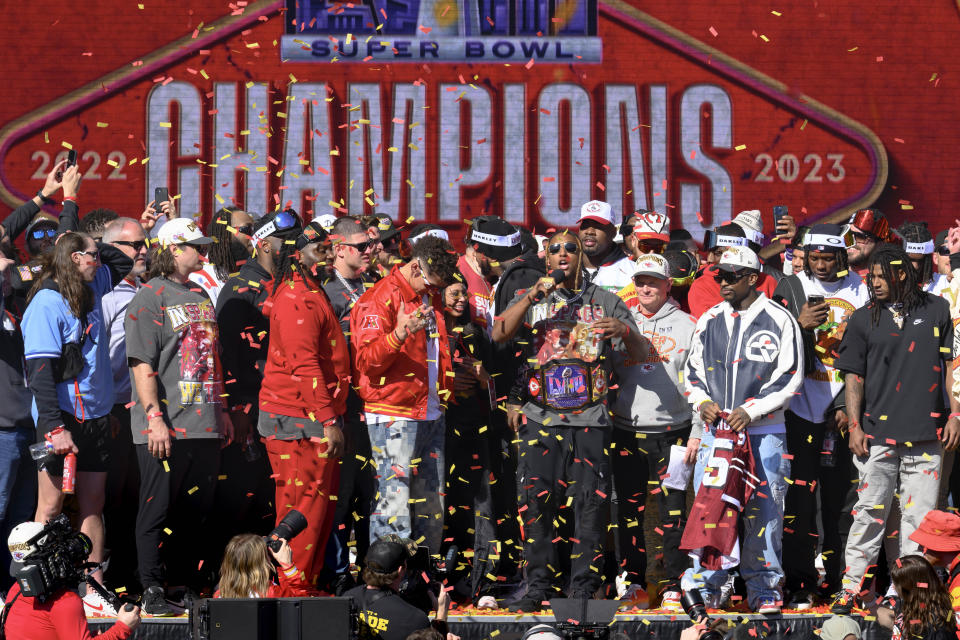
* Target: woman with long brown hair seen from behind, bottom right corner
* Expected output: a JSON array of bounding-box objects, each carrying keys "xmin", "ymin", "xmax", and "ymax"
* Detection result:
[{"xmin": 890, "ymin": 556, "xmax": 957, "ymax": 640}]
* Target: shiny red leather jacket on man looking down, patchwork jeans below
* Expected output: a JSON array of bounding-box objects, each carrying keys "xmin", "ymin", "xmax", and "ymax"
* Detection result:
[{"xmin": 350, "ymin": 267, "xmax": 453, "ymax": 420}]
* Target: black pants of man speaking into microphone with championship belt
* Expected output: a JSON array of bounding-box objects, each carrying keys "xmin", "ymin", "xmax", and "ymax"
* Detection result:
[{"xmin": 518, "ymin": 418, "xmax": 611, "ymax": 597}]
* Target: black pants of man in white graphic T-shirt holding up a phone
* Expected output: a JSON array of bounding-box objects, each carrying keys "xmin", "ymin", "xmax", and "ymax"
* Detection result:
[{"xmin": 783, "ymin": 411, "xmax": 857, "ymax": 593}]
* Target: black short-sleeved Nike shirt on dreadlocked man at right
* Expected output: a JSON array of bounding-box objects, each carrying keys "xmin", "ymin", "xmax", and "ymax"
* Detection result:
[{"xmin": 835, "ymin": 293, "xmax": 953, "ymax": 445}]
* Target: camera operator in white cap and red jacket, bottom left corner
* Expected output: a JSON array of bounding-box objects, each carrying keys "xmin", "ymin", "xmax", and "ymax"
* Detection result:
[{"xmin": 2, "ymin": 522, "xmax": 140, "ymax": 640}]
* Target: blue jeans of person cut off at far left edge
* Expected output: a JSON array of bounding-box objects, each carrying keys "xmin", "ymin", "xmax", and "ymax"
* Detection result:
[{"xmin": 0, "ymin": 428, "xmax": 37, "ymax": 591}]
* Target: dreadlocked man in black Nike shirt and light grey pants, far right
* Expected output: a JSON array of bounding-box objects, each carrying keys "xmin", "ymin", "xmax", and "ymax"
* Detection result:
[{"xmin": 832, "ymin": 245, "xmax": 960, "ymax": 613}]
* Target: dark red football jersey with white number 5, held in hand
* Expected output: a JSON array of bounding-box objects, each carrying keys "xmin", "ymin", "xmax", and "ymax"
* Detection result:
[{"xmin": 680, "ymin": 420, "xmax": 760, "ymax": 570}]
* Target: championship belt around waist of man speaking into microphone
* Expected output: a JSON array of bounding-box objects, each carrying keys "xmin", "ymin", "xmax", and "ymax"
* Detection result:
[{"xmin": 527, "ymin": 360, "xmax": 607, "ymax": 411}]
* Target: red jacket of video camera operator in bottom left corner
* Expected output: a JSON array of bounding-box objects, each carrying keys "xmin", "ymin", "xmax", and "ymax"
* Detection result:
[{"xmin": 5, "ymin": 582, "xmax": 133, "ymax": 640}]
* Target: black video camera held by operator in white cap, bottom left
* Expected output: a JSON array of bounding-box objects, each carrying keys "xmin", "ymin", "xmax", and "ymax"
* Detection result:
[{"xmin": 16, "ymin": 514, "xmax": 93, "ymax": 602}]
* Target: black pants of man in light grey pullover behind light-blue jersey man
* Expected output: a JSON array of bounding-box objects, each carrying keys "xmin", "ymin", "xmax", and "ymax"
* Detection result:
[{"xmin": 103, "ymin": 404, "xmax": 140, "ymax": 592}]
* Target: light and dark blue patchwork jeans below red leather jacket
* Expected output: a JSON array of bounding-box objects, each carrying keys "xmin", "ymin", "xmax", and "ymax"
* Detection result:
[{"xmin": 368, "ymin": 417, "xmax": 444, "ymax": 553}]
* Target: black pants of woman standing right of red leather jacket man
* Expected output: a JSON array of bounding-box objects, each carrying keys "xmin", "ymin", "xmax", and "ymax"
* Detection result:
[{"xmin": 441, "ymin": 416, "xmax": 500, "ymax": 601}]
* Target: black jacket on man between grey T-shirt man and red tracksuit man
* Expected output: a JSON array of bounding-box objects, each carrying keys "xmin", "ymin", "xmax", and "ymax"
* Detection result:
[{"xmin": 217, "ymin": 259, "xmax": 273, "ymax": 410}]
